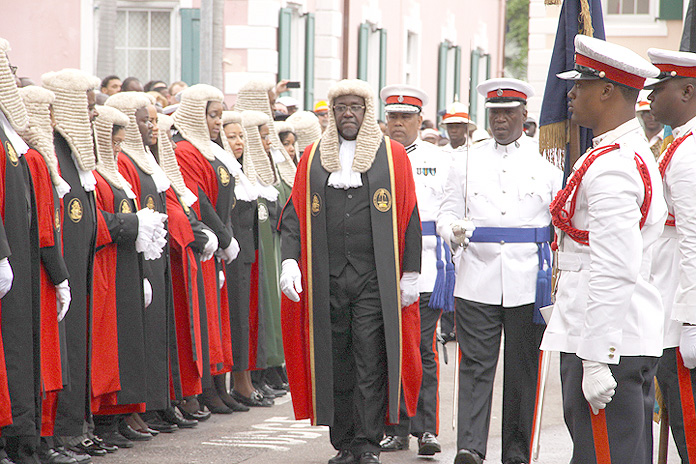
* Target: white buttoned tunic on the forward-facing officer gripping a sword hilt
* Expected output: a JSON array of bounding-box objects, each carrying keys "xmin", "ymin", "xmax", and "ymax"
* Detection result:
[{"xmin": 437, "ymin": 135, "xmax": 563, "ymax": 307}]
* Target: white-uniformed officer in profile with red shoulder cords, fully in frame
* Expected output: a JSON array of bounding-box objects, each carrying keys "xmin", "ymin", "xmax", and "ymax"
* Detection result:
[{"xmin": 541, "ymin": 35, "xmax": 667, "ymax": 464}]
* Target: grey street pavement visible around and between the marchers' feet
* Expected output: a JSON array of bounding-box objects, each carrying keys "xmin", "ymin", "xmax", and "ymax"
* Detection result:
[{"xmin": 93, "ymin": 342, "xmax": 681, "ymax": 464}]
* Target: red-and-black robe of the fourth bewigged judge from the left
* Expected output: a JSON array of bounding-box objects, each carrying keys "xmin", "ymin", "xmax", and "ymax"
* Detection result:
[{"xmin": 91, "ymin": 172, "xmax": 147, "ymax": 414}]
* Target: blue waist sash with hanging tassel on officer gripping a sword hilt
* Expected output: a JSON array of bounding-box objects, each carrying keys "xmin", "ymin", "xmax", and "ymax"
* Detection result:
[{"xmin": 470, "ymin": 226, "xmax": 552, "ymax": 324}]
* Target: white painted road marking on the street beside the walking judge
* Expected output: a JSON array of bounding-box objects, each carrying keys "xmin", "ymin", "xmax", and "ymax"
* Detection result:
[{"xmin": 202, "ymin": 416, "xmax": 329, "ymax": 451}]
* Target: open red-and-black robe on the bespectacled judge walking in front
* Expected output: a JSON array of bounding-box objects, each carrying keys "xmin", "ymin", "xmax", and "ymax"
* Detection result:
[{"xmin": 281, "ymin": 137, "xmax": 422, "ymax": 425}]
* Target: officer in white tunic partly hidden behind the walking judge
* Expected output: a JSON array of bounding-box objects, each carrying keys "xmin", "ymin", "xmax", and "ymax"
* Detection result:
[{"xmin": 380, "ymin": 85, "xmax": 454, "ymax": 456}]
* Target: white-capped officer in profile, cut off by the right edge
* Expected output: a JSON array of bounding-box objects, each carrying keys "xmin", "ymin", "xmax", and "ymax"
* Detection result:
[{"xmin": 646, "ymin": 48, "xmax": 696, "ymax": 462}]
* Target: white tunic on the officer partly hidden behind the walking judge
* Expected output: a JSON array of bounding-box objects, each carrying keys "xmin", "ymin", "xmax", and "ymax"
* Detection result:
[{"xmin": 406, "ymin": 136, "xmax": 452, "ymax": 293}]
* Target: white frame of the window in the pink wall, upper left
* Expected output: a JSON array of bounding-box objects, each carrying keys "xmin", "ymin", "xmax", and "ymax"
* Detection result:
[{"xmin": 116, "ymin": 0, "xmax": 181, "ymax": 84}]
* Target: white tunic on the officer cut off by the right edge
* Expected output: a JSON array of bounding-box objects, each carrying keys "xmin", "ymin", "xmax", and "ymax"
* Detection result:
[{"xmin": 650, "ymin": 118, "xmax": 696, "ymax": 348}]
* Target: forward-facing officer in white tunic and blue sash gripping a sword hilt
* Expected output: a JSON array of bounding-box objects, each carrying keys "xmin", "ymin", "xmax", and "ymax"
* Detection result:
[{"xmin": 437, "ymin": 78, "xmax": 562, "ymax": 464}]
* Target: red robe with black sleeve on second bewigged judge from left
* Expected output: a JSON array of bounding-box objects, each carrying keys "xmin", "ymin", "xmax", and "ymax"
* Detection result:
[{"xmin": 25, "ymin": 148, "xmax": 68, "ymax": 436}]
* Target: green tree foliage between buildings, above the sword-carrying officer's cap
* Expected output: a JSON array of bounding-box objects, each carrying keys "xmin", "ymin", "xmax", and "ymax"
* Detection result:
[{"xmin": 505, "ymin": 0, "xmax": 529, "ymax": 79}]
